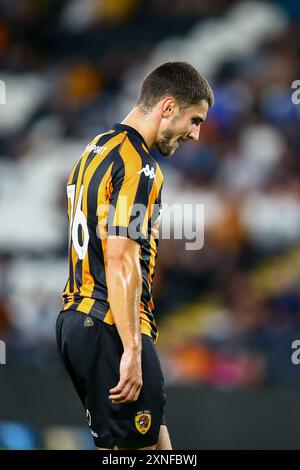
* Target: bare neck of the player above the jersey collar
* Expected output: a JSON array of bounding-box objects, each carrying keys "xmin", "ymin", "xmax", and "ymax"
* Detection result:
[{"xmin": 122, "ymin": 106, "xmax": 158, "ymax": 149}]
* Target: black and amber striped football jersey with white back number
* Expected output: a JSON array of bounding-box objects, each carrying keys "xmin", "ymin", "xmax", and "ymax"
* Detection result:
[{"xmin": 62, "ymin": 124, "xmax": 163, "ymax": 341}]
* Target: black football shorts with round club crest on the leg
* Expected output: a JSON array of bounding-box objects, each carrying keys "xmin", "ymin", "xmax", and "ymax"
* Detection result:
[{"xmin": 56, "ymin": 310, "xmax": 165, "ymax": 449}]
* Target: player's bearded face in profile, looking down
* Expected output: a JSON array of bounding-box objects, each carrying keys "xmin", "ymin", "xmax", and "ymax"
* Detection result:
[{"xmin": 155, "ymin": 100, "xmax": 208, "ymax": 157}]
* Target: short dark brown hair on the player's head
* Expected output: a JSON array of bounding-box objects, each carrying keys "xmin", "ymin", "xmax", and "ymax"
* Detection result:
[{"xmin": 137, "ymin": 62, "xmax": 214, "ymax": 110}]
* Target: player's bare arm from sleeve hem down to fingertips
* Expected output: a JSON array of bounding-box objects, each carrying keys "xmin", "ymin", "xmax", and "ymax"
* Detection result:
[{"xmin": 106, "ymin": 237, "xmax": 143, "ymax": 403}]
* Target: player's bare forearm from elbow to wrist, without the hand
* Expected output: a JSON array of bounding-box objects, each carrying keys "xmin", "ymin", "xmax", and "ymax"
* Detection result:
[{"xmin": 106, "ymin": 248, "xmax": 142, "ymax": 351}]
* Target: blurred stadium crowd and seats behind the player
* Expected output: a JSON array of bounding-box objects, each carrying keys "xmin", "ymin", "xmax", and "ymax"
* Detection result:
[{"xmin": 0, "ymin": 0, "xmax": 300, "ymax": 449}]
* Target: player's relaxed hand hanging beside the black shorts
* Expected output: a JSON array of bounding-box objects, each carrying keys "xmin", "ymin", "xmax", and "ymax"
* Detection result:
[{"xmin": 109, "ymin": 350, "xmax": 143, "ymax": 403}]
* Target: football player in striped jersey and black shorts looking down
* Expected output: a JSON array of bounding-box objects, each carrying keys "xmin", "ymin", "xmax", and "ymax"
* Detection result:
[{"xmin": 56, "ymin": 62, "xmax": 213, "ymax": 450}]
